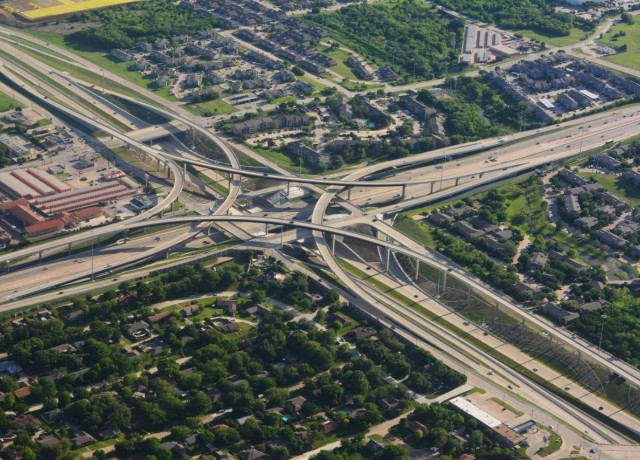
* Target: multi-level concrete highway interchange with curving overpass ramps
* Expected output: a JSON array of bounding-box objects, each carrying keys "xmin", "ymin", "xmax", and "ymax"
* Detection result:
[{"xmin": 0, "ymin": 27, "xmax": 640, "ymax": 458}]
